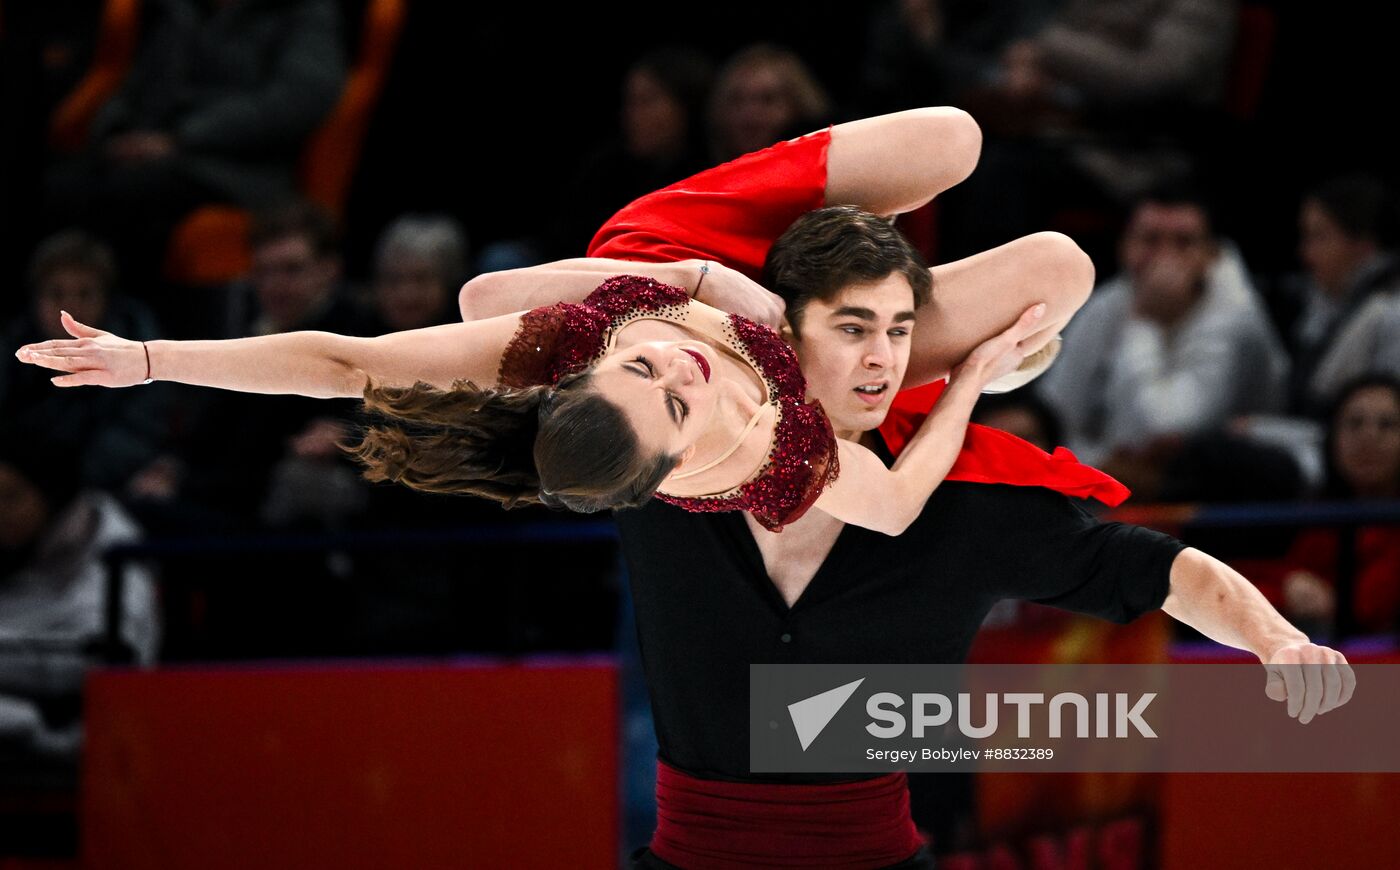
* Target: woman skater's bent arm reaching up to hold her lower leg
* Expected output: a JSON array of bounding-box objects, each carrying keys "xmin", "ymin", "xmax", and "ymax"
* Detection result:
[{"xmin": 816, "ymin": 304, "xmax": 1046, "ymax": 535}]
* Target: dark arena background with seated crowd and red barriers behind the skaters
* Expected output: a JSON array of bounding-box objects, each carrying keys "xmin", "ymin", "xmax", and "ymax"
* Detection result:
[{"xmin": 0, "ymin": 0, "xmax": 1400, "ymax": 870}]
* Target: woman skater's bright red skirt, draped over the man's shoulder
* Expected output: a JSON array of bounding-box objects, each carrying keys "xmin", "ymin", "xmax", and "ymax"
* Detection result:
[{"xmin": 588, "ymin": 129, "xmax": 1128, "ymax": 507}]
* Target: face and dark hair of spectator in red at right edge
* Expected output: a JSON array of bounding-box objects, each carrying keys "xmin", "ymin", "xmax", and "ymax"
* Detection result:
[{"xmin": 1333, "ymin": 387, "xmax": 1400, "ymax": 497}]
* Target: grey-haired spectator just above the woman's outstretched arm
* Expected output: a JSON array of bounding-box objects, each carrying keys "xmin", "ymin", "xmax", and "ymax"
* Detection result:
[{"xmin": 364, "ymin": 214, "xmax": 468, "ymax": 335}]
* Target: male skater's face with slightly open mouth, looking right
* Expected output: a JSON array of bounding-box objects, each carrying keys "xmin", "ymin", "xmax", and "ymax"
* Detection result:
[{"xmin": 794, "ymin": 273, "xmax": 914, "ymax": 440}]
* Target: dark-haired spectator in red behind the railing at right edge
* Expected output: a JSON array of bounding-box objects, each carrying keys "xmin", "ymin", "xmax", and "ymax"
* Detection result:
[{"xmin": 1282, "ymin": 374, "xmax": 1400, "ymax": 632}]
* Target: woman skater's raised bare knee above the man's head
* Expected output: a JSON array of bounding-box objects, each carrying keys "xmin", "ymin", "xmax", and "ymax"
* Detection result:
[{"xmin": 826, "ymin": 106, "xmax": 981, "ymax": 214}]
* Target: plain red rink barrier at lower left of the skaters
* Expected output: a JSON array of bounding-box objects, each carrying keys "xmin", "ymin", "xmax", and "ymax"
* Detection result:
[{"xmin": 81, "ymin": 658, "xmax": 617, "ymax": 870}]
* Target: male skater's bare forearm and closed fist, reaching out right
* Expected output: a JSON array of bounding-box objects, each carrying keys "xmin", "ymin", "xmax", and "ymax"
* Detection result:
[{"xmin": 1162, "ymin": 549, "xmax": 1357, "ymax": 724}]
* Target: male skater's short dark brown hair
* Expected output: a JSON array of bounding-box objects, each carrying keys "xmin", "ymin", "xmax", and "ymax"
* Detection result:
[{"xmin": 763, "ymin": 206, "xmax": 934, "ymax": 332}]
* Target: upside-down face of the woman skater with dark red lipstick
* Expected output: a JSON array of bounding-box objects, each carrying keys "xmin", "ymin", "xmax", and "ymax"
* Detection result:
[{"xmin": 592, "ymin": 340, "xmax": 724, "ymax": 457}]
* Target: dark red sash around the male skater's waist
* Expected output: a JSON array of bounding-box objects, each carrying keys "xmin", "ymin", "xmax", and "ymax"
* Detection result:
[{"xmin": 650, "ymin": 762, "xmax": 924, "ymax": 870}]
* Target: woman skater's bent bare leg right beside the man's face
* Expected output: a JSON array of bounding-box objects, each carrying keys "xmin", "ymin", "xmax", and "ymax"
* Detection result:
[{"xmin": 904, "ymin": 233, "xmax": 1093, "ymax": 388}]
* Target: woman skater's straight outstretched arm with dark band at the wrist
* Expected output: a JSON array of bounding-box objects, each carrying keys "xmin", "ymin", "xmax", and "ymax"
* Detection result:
[{"xmin": 15, "ymin": 312, "xmax": 519, "ymax": 399}]
